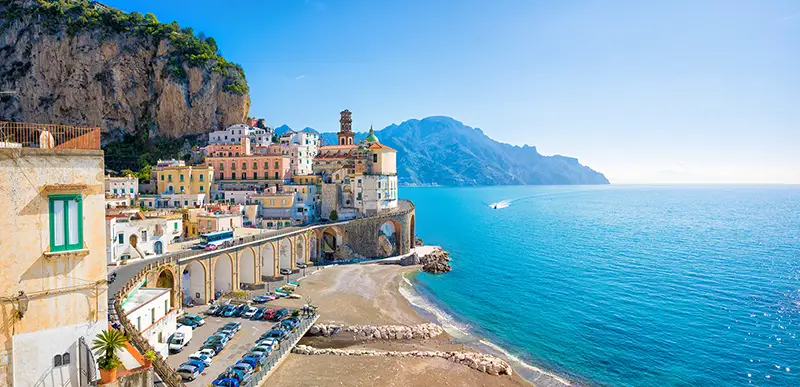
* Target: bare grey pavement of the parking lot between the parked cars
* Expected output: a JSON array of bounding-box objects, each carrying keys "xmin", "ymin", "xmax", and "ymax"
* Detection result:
[{"xmin": 167, "ymin": 301, "xmax": 308, "ymax": 387}]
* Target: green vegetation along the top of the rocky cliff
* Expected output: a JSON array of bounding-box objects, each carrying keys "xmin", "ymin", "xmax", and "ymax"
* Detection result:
[{"xmin": 0, "ymin": 0, "xmax": 249, "ymax": 95}]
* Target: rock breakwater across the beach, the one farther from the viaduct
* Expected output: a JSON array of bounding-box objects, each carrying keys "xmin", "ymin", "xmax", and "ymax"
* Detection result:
[{"xmin": 292, "ymin": 345, "xmax": 513, "ymax": 375}]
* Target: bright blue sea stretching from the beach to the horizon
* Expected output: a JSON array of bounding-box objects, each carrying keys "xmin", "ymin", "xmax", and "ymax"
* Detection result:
[{"xmin": 400, "ymin": 186, "xmax": 800, "ymax": 386}]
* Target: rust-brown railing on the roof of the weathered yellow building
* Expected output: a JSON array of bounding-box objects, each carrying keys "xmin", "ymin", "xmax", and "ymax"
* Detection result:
[{"xmin": 0, "ymin": 121, "xmax": 100, "ymax": 150}]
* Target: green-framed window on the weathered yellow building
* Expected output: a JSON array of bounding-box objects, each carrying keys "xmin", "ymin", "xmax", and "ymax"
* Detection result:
[{"xmin": 50, "ymin": 195, "xmax": 83, "ymax": 251}]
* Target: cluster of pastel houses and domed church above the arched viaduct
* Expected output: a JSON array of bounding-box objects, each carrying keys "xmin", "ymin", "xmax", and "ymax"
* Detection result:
[{"xmin": 105, "ymin": 110, "xmax": 397, "ymax": 264}]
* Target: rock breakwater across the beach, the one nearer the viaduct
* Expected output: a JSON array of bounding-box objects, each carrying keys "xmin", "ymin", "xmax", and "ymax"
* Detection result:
[{"xmin": 308, "ymin": 323, "xmax": 444, "ymax": 340}]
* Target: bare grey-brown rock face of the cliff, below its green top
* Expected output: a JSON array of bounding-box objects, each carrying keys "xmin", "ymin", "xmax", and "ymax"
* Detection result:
[{"xmin": 0, "ymin": 1, "xmax": 250, "ymax": 143}]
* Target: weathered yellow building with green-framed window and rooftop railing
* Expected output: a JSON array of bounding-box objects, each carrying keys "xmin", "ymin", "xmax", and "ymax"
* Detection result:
[{"xmin": 0, "ymin": 122, "xmax": 108, "ymax": 386}]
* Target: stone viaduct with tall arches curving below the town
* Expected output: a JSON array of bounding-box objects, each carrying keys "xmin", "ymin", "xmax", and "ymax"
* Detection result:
[{"xmin": 139, "ymin": 200, "xmax": 416, "ymax": 306}]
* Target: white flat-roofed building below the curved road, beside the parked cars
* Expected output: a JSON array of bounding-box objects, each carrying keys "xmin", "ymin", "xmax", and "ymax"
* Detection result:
[{"xmin": 122, "ymin": 288, "xmax": 178, "ymax": 358}]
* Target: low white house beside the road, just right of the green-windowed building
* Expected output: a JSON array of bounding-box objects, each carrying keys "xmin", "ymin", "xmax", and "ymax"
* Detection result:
[{"xmin": 106, "ymin": 215, "xmax": 183, "ymax": 264}]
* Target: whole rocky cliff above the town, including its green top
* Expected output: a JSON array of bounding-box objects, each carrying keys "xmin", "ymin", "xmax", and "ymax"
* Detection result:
[{"xmin": 0, "ymin": 0, "xmax": 250, "ymax": 143}]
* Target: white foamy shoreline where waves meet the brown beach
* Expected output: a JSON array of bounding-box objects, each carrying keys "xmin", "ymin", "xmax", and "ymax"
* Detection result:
[{"xmin": 398, "ymin": 266, "xmax": 577, "ymax": 387}]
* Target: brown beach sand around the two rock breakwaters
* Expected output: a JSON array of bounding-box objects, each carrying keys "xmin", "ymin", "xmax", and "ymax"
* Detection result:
[{"xmin": 267, "ymin": 265, "xmax": 531, "ymax": 387}]
